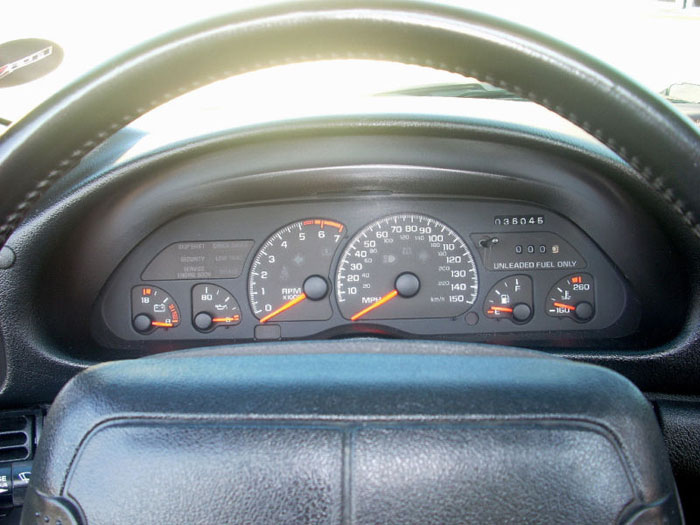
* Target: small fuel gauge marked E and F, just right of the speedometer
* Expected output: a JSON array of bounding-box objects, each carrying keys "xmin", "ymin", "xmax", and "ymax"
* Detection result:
[{"xmin": 484, "ymin": 275, "xmax": 532, "ymax": 323}]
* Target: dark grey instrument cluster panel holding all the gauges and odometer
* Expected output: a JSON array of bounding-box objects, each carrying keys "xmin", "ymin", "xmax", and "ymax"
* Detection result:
[{"xmin": 95, "ymin": 195, "xmax": 640, "ymax": 346}]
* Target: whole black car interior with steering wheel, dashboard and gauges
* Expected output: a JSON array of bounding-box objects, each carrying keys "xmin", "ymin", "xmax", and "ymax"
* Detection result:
[{"xmin": 0, "ymin": 0, "xmax": 700, "ymax": 525}]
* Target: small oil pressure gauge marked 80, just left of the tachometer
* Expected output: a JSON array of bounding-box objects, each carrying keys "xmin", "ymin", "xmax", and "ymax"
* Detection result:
[{"xmin": 192, "ymin": 283, "xmax": 241, "ymax": 332}]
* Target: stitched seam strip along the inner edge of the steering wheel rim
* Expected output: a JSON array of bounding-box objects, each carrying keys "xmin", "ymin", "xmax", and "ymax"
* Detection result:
[{"xmin": 0, "ymin": 52, "xmax": 700, "ymax": 247}]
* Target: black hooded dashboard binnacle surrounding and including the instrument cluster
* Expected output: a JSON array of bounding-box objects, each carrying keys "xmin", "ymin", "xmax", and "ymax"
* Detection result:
[{"xmin": 0, "ymin": 124, "xmax": 688, "ymax": 368}]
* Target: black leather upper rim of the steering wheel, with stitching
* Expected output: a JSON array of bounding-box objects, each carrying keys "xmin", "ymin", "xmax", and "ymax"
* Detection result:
[{"xmin": 0, "ymin": 0, "xmax": 700, "ymax": 246}]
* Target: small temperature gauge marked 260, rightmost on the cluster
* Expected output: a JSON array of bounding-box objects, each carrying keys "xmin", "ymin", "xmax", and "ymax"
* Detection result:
[{"xmin": 545, "ymin": 273, "xmax": 595, "ymax": 323}]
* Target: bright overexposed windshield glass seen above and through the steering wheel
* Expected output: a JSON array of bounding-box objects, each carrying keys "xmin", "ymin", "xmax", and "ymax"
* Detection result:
[{"xmin": 0, "ymin": 0, "xmax": 700, "ymax": 126}]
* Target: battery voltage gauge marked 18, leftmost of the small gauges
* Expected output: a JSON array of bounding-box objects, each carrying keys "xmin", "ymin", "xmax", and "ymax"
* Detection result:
[{"xmin": 131, "ymin": 285, "xmax": 180, "ymax": 334}]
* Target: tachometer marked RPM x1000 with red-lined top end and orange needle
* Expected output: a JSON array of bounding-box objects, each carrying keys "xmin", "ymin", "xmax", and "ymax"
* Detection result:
[{"xmin": 248, "ymin": 219, "xmax": 345, "ymax": 323}]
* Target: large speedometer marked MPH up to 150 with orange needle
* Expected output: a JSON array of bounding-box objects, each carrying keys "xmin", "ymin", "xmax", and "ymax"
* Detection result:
[{"xmin": 336, "ymin": 213, "xmax": 479, "ymax": 321}]
